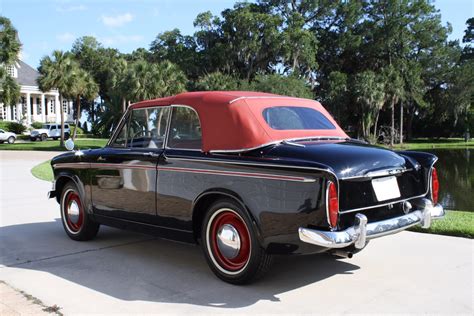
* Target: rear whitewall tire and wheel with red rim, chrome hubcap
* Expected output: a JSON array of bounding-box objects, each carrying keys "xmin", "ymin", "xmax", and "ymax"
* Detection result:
[{"xmin": 201, "ymin": 199, "xmax": 273, "ymax": 284}]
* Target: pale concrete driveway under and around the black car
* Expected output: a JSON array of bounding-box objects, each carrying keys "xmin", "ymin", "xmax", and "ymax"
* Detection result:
[{"xmin": 0, "ymin": 151, "xmax": 474, "ymax": 314}]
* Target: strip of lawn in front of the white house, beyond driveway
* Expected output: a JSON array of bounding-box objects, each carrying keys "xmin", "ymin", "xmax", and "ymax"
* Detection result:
[{"xmin": 0, "ymin": 138, "xmax": 107, "ymax": 151}]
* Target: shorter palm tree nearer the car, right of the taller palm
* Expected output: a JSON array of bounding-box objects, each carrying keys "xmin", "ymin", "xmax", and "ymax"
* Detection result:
[{"xmin": 68, "ymin": 65, "xmax": 99, "ymax": 140}]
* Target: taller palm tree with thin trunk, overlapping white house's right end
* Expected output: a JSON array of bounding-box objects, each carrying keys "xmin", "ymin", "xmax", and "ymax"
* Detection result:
[{"xmin": 38, "ymin": 50, "xmax": 78, "ymax": 146}]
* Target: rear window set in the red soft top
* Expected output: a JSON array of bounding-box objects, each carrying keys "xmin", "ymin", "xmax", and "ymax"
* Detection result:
[{"xmin": 262, "ymin": 106, "xmax": 336, "ymax": 130}]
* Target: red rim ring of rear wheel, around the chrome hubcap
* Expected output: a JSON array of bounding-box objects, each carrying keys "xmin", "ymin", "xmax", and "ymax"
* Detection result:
[{"xmin": 209, "ymin": 210, "xmax": 250, "ymax": 272}]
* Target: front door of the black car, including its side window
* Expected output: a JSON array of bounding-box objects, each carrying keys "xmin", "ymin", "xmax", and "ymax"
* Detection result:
[{"xmin": 91, "ymin": 106, "xmax": 170, "ymax": 223}]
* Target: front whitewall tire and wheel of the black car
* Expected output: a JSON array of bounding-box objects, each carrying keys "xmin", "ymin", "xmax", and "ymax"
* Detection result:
[{"xmin": 60, "ymin": 181, "xmax": 100, "ymax": 241}]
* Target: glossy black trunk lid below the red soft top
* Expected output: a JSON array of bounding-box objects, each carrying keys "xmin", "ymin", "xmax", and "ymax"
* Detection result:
[{"xmin": 264, "ymin": 140, "xmax": 418, "ymax": 179}]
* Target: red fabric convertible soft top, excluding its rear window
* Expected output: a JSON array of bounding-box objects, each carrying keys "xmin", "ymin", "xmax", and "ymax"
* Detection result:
[{"xmin": 131, "ymin": 91, "xmax": 348, "ymax": 152}]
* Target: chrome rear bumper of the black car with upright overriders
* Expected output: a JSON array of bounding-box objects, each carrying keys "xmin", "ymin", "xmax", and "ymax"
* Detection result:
[{"xmin": 299, "ymin": 199, "xmax": 445, "ymax": 249}]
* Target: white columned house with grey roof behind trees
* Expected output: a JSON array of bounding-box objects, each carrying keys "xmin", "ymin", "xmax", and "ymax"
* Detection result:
[{"xmin": 0, "ymin": 60, "xmax": 73, "ymax": 124}]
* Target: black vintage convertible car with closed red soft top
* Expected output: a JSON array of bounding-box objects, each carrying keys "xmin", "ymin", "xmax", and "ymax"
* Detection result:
[{"xmin": 49, "ymin": 92, "xmax": 444, "ymax": 284}]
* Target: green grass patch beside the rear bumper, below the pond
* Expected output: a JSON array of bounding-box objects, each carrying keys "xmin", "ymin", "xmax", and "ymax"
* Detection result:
[{"xmin": 410, "ymin": 211, "xmax": 474, "ymax": 239}]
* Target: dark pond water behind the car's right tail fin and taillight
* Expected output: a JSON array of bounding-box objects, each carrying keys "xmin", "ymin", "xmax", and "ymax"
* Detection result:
[{"xmin": 420, "ymin": 149, "xmax": 474, "ymax": 212}]
